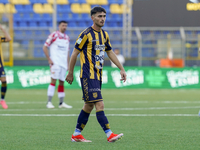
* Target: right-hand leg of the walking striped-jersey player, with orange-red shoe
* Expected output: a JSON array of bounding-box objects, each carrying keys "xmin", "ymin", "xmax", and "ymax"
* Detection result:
[{"xmin": 95, "ymin": 98, "xmax": 123, "ymax": 142}]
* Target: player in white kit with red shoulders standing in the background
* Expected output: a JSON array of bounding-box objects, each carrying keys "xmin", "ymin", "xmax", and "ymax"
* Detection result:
[{"xmin": 43, "ymin": 21, "xmax": 72, "ymax": 108}]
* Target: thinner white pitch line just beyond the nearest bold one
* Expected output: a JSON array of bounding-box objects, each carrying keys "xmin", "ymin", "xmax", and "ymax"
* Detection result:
[{"xmin": 0, "ymin": 106, "xmax": 200, "ymax": 112}]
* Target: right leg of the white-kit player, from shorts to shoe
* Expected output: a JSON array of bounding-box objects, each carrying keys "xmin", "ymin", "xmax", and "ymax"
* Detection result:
[{"xmin": 58, "ymin": 67, "xmax": 72, "ymax": 108}]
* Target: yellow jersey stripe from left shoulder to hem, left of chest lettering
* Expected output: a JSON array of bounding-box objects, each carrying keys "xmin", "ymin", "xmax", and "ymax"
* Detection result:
[{"xmin": 87, "ymin": 33, "xmax": 94, "ymax": 79}]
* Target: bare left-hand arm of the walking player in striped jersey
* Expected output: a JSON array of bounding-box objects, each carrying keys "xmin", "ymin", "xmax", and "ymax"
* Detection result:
[{"xmin": 65, "ymin": 49, "xmax": 80, "ymax": 84}]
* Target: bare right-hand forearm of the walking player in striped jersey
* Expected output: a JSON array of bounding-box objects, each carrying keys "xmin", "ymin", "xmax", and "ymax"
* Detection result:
[{"xmin": 106, "ymin": 50, "xmax": 126, "ymax": 82}]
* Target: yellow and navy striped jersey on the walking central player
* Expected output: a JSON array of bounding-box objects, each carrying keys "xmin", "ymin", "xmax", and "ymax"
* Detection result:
[{"xmin": 75, "ymin": 27, "xmax": 112, "ymax": 80}]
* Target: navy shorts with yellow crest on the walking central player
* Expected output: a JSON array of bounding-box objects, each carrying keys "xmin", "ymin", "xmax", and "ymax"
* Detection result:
[{"xmin": 81, "ymin": 78, "xmax": 103, "ymax": 103}]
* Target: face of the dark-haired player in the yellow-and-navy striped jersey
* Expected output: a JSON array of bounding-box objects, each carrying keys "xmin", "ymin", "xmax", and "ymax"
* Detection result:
[{"xmin": 92, "ymin": 12, "xmax": 106, "ymax": 27}]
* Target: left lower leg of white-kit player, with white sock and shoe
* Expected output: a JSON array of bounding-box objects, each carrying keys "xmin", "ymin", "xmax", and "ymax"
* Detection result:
[{"xmin": 47, "ymin": 78, "xmax": 57, "ymax": 108}]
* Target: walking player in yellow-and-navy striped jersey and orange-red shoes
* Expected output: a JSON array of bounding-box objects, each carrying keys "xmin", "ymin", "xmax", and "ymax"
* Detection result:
[{"xmin": 66, "ymin": 6, "xmax": 126, "ymax": 142}]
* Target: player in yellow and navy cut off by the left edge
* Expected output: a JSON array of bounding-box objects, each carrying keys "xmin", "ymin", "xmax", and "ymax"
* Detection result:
[{"xmin": 0, "ymin": 24, "xmax": 11, "ymax": 109}]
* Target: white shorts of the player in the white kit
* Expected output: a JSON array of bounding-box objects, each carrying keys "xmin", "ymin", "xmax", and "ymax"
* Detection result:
[{"xmin": 50, "ymin": 65, "xmax": 67, "ymax": 81}]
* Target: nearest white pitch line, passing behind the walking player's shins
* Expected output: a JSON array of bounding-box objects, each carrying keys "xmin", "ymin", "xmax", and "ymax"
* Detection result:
[{"xmin": 0, "ymin": 114, "xmax": 198, "ymax": 117}]
